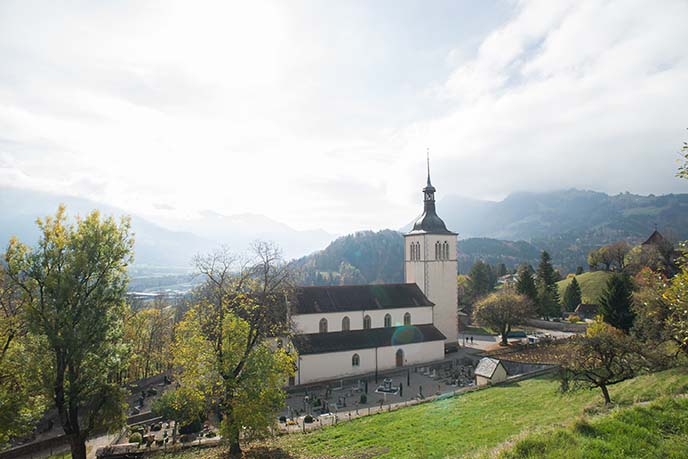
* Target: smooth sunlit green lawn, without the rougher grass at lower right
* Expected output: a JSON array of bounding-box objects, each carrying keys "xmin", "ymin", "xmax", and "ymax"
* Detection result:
[{"xmin": 272, "ymin": 370, "xmax": 688, "ymax": 458}]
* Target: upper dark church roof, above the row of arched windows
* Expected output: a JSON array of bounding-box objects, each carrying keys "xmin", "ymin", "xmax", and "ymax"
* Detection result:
[{"xmin": 291, "ymin": 284, "xmax": 434, "ymax": 314}]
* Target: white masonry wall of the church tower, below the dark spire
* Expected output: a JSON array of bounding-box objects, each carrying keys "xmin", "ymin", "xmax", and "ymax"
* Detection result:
[{"xmin": 404, "ymin": 234, "xmax": 458, "ymax": 343}]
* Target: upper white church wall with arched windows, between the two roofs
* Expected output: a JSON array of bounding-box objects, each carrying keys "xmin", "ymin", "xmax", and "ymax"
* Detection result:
[{"xmin": 292, "ymin": 306, "xmax": 433, "ymax": 334}]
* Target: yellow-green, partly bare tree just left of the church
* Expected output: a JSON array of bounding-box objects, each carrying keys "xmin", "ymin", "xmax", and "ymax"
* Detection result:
[{"xmin": 174, "ymin": 243, "xmax": 294, "ymax": 455}]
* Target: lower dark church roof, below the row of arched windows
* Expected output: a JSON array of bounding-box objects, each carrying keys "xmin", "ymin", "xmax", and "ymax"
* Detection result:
[{"xmin": 292, "ymin": 324, "xmax": 446, "ymax": 355}]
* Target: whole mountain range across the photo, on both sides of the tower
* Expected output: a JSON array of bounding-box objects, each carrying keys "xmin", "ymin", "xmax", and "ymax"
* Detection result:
[{"xmin": 0, "ymin": 187, "xmax": 688, "ymax": 283}]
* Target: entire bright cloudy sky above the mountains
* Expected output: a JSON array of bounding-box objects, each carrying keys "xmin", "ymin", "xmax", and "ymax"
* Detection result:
[{"xmin": 0, "ymin": 0, "xmax": 688, "ymax": 234}]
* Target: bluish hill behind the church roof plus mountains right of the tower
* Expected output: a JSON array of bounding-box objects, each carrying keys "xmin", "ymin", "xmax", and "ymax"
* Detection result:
[{"xmin": 298, "ymin": 189, "xmax": 688, "ymax": 285}]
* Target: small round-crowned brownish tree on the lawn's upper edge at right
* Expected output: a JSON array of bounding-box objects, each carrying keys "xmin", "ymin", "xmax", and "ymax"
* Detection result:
[{"xmin": 563, "ymin": 322, "xmax": 645, "ymax": 404}]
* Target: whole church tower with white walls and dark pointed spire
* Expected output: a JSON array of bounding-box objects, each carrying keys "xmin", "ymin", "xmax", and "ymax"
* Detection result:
[{"xmin": 404, "ymin": 159, "xmax": 459, "ymax": 346}]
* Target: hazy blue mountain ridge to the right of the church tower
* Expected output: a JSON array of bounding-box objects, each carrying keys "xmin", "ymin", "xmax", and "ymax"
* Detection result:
[{"xmin": 414, "ymin": 189, "xmax": 688, "ymax": 271}]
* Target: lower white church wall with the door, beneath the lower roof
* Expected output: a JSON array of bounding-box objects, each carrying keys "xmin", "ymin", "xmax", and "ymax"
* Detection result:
[{"xmin": 296, "ymin": 341, "xmax": 444, "ymax": 384}]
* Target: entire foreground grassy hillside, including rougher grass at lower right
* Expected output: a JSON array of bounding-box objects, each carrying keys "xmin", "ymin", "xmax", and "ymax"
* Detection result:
[{"xmin": 153, "ymin": 369, "xmax": 688, "ymax": 459}]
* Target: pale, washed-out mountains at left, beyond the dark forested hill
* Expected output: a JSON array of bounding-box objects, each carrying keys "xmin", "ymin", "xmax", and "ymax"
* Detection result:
[{"xmin": 0, "ymin": 187, "xmax": 333, "ymax": 277}]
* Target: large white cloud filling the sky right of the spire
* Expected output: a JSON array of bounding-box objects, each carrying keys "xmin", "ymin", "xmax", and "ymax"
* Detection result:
[{"xmin": 400, "ymin": 1, "xmax": 688, "ymax": 198}]
